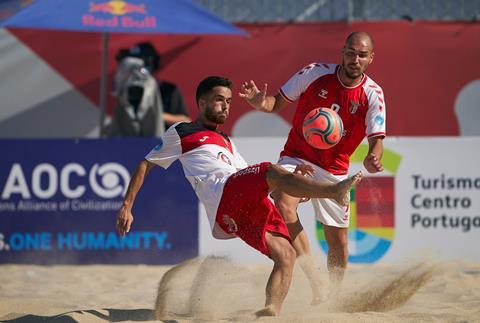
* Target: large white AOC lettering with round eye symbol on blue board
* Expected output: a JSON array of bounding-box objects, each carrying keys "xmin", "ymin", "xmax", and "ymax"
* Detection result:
[{"xmin": 1, "ymin": 163, "xmax": 130, "ymax": 200}]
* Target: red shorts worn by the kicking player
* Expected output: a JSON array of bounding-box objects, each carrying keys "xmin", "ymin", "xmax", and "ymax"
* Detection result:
[{"xmin": 216, "ymin": 163, "xmax": 291, "ymax": 257}]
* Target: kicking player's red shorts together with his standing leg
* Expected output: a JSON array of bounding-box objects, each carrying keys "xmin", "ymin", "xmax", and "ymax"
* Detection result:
[{"xmin": 215, "ymin": 163, "xmax": 296, "ymax": 316}]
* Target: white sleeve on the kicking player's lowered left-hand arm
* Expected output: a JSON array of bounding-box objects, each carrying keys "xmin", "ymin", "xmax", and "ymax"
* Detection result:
[{"xmin": 145, "ymin": 126, "xmax": 182, "ymax": 169}]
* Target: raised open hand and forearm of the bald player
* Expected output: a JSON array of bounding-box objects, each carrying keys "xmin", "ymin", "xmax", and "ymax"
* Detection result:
[{"xmin": 238, "ymin": 80, "xmax": 289, "ymax": 113}]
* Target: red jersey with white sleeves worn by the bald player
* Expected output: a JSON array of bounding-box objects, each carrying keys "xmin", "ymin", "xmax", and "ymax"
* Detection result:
[{"xmin": 280, "ymin": 63, "xmax": 386, "ymax": 175}]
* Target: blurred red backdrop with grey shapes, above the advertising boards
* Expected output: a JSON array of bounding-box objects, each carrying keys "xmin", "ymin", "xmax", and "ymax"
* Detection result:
[{"xmin": 0, "ymin": 20, "xmax": 480, "ymax": 138}]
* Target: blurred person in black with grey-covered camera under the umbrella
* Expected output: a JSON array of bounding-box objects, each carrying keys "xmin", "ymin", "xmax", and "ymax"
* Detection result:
[{"xmin": 108, "ymin": 42, "xmax": 190, "ymax": 137}]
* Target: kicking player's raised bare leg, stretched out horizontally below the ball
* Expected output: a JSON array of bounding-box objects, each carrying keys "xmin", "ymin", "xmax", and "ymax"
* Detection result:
[{"xmin": 266, "ymin": 164, "xmax": 362, "ymax": 205}]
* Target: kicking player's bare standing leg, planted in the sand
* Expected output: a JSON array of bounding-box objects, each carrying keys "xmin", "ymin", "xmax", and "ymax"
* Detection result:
[{"xmin": 256, "ymin": 231, "xmax": 296, "ymax": 316}]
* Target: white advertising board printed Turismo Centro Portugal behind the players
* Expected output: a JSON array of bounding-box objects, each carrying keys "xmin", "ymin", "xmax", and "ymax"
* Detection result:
[{"xmin": 200, "ymin": 137, "xmax": 480, "ymax": 264}]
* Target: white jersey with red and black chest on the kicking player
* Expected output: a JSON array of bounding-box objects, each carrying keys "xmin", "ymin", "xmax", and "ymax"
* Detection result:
[{"xmin": 145, "ymin": 122, "xmax": 248, "ymax": 233}]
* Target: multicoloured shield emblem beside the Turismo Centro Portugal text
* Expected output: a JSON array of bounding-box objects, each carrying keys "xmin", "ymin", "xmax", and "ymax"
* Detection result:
[{"xmin": 317, "ymin": 144, "xmax": 401, "ymax": 263}]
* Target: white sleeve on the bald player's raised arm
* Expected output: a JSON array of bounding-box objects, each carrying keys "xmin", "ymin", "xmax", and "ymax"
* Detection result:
[{"xmin": 279, "ymin": 63, "xmax": 336, "ymax": 102}]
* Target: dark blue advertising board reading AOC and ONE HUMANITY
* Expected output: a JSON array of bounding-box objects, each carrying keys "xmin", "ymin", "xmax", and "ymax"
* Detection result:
[{"xmin": 0, "ymin": 138, "xmax": 198, "ymax": 264}]
